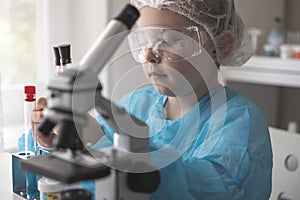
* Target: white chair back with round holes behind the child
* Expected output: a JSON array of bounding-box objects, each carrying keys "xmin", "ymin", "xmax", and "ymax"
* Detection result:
[{"xmin": 269, "ymin": 128, "xmax": 300, "ymax": 200}]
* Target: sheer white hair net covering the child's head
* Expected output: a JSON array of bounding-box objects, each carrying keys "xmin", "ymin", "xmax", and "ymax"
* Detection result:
[{"xmin": 131, "ymin": 0, "xmax": 253, "ymax": 66}]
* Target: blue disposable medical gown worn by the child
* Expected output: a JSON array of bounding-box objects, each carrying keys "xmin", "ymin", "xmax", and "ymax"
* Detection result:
[{"xmin": 89, "ymin": 86, "xmax": 272, "ymax": 200}]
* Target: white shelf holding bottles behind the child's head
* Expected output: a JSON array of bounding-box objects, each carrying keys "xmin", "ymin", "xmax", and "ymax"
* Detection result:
[{"xmin": 220, "ymin": 56, "xmax": 300, "ymax": 88}]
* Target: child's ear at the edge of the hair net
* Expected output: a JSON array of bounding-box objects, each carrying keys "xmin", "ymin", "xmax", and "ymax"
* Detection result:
[{"xmin": 215, "ymin": 30, "xmax": 235, "ymax": 59}]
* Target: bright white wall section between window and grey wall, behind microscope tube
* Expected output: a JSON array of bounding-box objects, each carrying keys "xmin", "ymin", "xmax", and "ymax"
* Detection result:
[{"xmin": 39, "ymin": 0, "xmax": 108, "ymax": 74}]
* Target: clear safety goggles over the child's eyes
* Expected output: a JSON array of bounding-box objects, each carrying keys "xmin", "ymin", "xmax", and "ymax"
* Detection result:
[{"xmin": 128, "ymin": 26, "xmax": 204, "ymax": 63}]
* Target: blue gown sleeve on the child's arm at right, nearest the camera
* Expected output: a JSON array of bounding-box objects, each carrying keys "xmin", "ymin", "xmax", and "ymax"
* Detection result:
[{"xmin": 152, "ymin": 106, "xmax": 272, "ymax": 200}]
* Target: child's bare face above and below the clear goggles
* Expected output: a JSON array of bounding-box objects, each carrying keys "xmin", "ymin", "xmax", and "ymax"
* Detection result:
[{"xmin": 138, "ymin": 7, "xmax": 214, "ymax": 96}]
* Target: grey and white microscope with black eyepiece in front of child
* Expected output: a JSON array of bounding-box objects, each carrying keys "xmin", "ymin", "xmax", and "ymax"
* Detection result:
[{"xmin": 20, "ymin": 4, "xmax": 160, "ymax": 200}]
